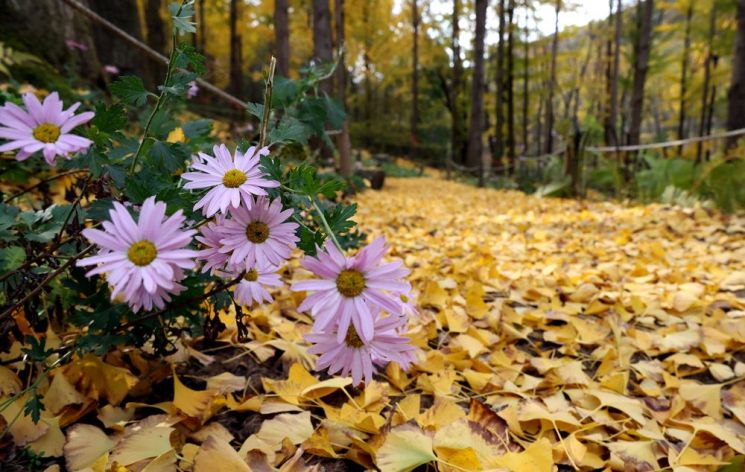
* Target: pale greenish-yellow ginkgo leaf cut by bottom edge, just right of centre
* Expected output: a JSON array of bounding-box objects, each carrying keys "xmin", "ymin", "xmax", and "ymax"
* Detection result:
[{"xmin": 375, "ymin": 424, "xmax": 437, "ymax": 472}]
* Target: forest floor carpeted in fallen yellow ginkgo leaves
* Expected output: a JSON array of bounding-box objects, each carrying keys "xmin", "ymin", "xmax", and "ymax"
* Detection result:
[{"xmin": 0, "ymin": 177, "xmax": 745, "ymax": 472}]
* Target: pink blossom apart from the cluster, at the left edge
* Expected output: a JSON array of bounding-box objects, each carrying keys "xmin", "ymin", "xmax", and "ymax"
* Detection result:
[{"xmin": 0, "ymin": 92, "xmax": 94, "ymax": 165}]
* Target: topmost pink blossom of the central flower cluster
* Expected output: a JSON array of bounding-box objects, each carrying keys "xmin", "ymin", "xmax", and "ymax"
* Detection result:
[{"xmin": 181, "ymin": 144, "xmax": 279, "ymax": 218}]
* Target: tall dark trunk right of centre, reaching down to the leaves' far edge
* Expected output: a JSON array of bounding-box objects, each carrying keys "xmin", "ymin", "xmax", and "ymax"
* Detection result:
[{"xmin": 468, "ymin": 0, "xmax": 489, "ymax": 185}]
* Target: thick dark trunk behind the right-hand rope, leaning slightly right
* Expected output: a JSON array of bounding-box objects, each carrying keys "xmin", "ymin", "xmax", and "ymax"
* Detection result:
[{"xmin": 627, "ymin": 0, "xmax": 654, "ymax": 146}]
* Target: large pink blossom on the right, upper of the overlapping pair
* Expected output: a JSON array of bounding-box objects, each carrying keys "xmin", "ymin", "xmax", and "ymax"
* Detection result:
[{"xmin": 292, "ymin": 236, "xmax": 411, "ymax": 342}]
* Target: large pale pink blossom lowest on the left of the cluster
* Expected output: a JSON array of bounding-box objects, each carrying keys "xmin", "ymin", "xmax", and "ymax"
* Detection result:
[{"xmin": 77, "ymin": 197, "xmax": 197, "ymax": 311}]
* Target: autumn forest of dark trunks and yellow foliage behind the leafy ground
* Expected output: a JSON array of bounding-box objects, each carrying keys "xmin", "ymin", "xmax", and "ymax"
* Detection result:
[{"xmin": 2, "ymin": 0, "xmax": 745, "ymax": 210}]
